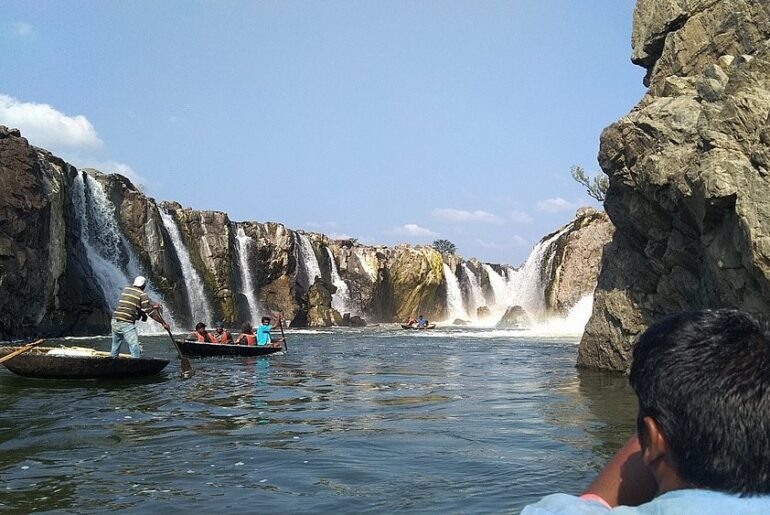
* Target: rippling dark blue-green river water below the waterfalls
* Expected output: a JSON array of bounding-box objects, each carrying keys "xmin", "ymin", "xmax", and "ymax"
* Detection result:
[{"xmin": 0, "ymin": 326, "xmax": 636, "ymax": 513}]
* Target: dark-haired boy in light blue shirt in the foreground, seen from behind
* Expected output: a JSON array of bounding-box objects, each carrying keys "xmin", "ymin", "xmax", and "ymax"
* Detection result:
[{"xmin": 522, "ymin": 309, "xmax": 770, "ymax": 515}]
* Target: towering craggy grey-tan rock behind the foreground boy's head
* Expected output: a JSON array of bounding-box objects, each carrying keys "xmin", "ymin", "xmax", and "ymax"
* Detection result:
[{"xmin": 578, "ymin": 0, "xmax": 770, "ymax": 371}]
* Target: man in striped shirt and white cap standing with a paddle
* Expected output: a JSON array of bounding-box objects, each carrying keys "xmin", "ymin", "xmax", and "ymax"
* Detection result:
[{"xmin": 110, "ymin": 275, "xmax": 169, "ymax": 358}]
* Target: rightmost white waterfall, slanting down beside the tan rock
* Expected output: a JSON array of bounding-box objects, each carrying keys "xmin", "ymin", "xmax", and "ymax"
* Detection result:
[{"xmin": 507, "ymin": 228, "xmax": 566, "ymax": 317}]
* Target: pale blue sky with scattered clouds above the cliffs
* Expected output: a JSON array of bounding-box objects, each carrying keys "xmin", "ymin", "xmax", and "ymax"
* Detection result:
[{"xmin": 0, "ymin": 0, "xmax": 644, "ymax": 265}]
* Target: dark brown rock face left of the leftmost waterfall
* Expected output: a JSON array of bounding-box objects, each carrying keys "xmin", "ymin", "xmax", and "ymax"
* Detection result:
[{"xmin": 0, "ymin": 126, "xmax": 109, "ymax": 340}]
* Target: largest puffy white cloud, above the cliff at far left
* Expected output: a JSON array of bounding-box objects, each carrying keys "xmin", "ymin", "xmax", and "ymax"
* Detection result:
[{"xmin": 0, "ymin": 94, "xmax": 103, "ymax": 153}]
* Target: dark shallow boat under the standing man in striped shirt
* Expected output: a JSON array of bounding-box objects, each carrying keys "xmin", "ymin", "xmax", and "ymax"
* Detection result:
[{"xmin": 0, "ymin": 347, "xmax": 169, "ymax": 379}]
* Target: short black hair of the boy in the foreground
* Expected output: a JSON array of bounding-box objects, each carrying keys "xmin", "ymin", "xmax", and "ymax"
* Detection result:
[{"xmin": 630, "ymin": 309, "xmax": 770, "ymax": 495}]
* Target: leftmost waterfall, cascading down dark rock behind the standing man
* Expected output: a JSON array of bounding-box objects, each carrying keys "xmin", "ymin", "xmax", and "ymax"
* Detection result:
[{"xmin": 72, "ymin": 172, "xmax": 176, "ymax": 334}]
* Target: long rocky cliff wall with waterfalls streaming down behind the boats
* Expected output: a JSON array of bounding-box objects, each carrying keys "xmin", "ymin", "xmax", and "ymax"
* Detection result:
[{"xmin": 0, "ymin": 127, "xmax": 610, "ymax": 339}]
